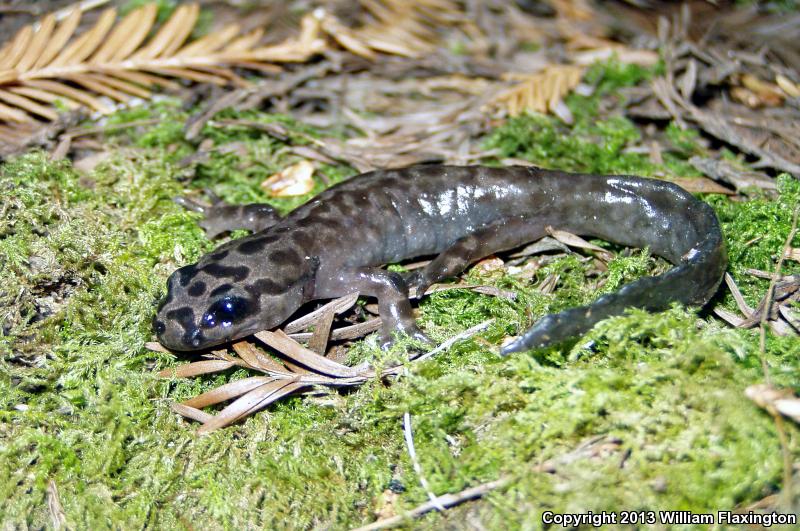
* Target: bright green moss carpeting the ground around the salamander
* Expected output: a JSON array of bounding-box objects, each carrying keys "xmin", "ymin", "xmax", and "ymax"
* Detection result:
[{"xmin": 0, "ymin": 64, "xmax": 800, "ymax": 529}]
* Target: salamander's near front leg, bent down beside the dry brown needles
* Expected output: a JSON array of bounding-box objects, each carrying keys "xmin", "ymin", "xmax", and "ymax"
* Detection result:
[{"xmin": 315, "ymin": 267, "xmax": 431, "ymax": 349}]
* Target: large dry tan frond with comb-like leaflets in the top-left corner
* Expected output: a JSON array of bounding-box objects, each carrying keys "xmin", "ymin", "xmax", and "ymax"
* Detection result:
[{"xmin": 0, "ymin": 4, "xmax": 325, "ymax": 123}]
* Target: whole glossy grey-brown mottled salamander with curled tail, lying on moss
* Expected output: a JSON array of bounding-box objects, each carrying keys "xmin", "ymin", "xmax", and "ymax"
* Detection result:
[{"xmin": 154, "ymin": 166, "xmax": 727, "ymax": 354}]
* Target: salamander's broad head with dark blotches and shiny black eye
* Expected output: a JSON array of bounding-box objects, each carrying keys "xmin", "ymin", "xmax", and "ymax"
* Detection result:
[{"xmin": 153, "ymin": 237, "xmax": 314, "ymax": 351}]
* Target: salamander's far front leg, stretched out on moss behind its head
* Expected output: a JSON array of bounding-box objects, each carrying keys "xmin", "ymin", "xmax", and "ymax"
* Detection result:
[{"xmin": 175, "ymin": 192, "xmax": 281, "ymax": 239}]
